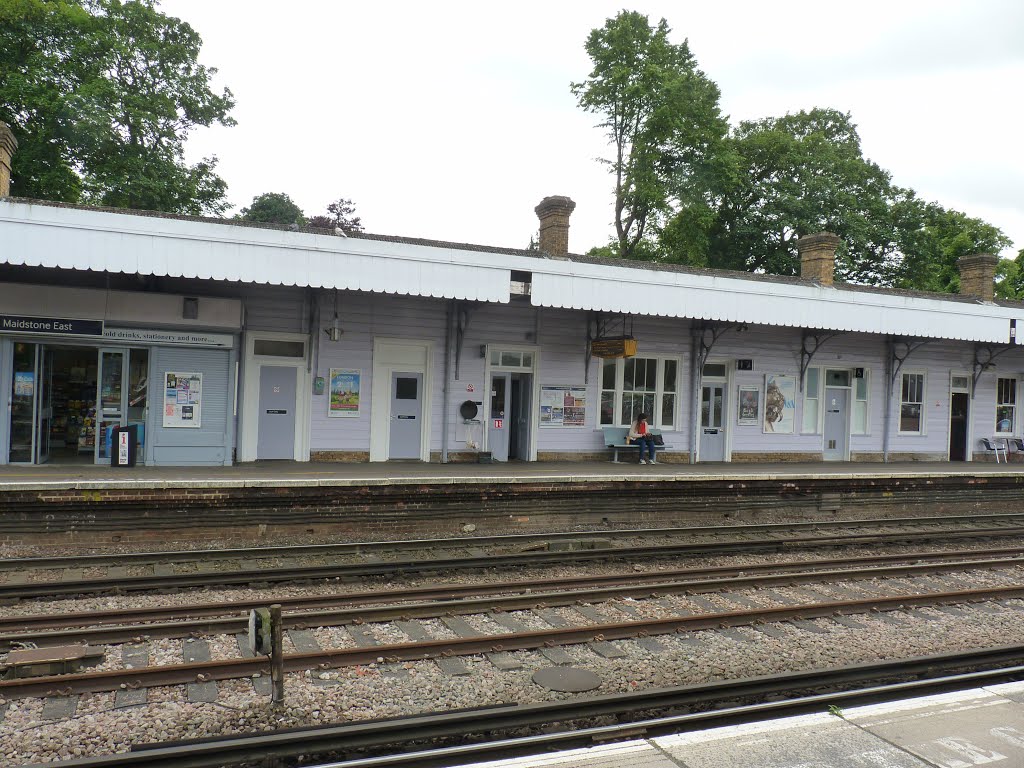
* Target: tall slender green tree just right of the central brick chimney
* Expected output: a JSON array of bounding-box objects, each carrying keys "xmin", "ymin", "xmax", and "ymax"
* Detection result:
[{"xmin": 571, "ymin": 11, "xmax": 728, "ymax": 258}]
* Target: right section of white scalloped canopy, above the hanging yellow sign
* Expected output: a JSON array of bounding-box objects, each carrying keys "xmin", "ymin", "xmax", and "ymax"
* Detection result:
[{"xmin": 531, "ymin": 263, "xmax": 1024, "ymax": 343}]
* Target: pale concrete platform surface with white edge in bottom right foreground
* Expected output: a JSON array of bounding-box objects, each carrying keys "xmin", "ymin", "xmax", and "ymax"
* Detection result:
[{"xmin": 467, "ymin": 683, "xmax": 1024, "ymax": 768}]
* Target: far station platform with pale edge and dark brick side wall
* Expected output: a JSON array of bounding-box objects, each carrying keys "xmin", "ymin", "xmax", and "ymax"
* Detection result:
[{"xmin": 0, "ymin": 461, "xmax": 1024, "ymax": 546}]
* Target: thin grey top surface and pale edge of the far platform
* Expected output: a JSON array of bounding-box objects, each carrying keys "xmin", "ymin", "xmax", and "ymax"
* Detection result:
[{"xmin": 0, "ymin": 462, "xmax": 1024, "ymax": 493}]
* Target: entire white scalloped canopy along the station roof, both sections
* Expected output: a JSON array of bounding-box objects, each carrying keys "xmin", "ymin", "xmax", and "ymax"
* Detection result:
[{"xmin": 0, "ymin": 199, "xmax": 1024, "ymax": 343}]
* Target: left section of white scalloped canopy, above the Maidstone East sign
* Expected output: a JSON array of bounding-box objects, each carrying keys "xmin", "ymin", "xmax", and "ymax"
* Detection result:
[{"xmin": 0, "ymin": 202, "xmax": 511, "ymax": 302}]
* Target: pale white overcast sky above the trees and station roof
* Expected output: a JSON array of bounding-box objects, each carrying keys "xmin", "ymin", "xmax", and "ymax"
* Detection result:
[{"xmin": 161, "ymin": 0, "xmax": 1024, "ymax": 256}]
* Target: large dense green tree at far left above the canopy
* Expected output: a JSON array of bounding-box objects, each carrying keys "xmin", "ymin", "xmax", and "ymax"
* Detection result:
[{"xmin": 0, "ymin": 0, "xmax": 234, "ymax": 214}]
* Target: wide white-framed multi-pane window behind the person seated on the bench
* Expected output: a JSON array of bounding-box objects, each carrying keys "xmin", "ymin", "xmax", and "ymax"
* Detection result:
[{"xmin": 601, "ymin": 357, "xmax": 679, "ymax": 429}]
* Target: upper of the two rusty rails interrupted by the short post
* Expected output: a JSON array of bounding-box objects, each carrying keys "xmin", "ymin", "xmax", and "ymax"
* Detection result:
[{"xmin": 0, "ymin": 550, "xmax": 1024, "ymax": 650}]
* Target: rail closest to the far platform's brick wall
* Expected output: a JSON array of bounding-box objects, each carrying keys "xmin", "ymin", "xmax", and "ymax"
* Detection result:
[{"xmin": 0, "ymin": 512, "xmax": 1024, "ymax": 571}]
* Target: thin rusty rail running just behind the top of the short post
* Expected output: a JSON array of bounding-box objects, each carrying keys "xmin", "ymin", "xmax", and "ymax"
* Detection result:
[{"xmin": 0, "ymin": 547, "xmax": 1022, "ymax": 634}]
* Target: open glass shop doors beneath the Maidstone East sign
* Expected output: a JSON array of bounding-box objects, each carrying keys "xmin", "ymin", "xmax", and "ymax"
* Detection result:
[{"xmin": 7, "ymin": 342, "xmax": 150, "ymax": 464}]
